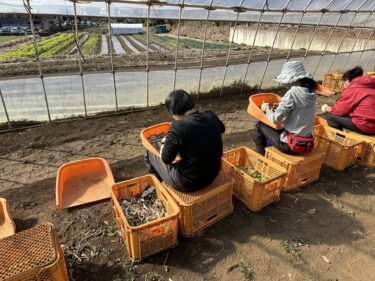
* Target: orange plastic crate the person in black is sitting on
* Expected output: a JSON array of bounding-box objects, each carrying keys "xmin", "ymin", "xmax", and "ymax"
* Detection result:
[{"xmin": 163, "ymin": 172, "xmax": 234, "ymax": 237}]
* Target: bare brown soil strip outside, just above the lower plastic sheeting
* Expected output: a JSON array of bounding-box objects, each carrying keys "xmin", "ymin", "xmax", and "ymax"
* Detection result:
[{"xmin": 0, "ymin": 47, "xmax": 317, "ymax": 79}]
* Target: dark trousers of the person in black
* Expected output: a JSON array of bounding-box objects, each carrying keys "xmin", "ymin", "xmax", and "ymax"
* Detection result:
[{"xmin": 144, "ymin": 150, "xmax": 191, "ymax": 192}]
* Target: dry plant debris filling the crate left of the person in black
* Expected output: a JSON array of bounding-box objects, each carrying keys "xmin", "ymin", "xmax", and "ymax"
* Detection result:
[{"xmin": 120, "ymin": 185, "xmax": 166, "ymax": 226}]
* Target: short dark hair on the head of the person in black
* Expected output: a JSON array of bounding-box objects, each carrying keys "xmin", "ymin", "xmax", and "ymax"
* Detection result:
[{"xmin": 165, "ymin": 90, "xmax": 194, "ymax": 115}]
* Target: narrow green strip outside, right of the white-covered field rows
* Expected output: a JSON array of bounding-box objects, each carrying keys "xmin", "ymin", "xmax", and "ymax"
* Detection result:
[{"xmin": 150, "ymin": 34, "xmax": 241, "ymax": 49}]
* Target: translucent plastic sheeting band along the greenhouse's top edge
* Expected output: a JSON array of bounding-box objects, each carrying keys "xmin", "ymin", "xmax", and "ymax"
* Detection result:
[{"xmin": 0, "ymin": 0, "xmax": 375, "ymax": 27}]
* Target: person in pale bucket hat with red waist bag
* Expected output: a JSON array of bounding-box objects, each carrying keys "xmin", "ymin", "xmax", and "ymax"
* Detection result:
[{"xmin": 254, "ymin": 61, "xmax": 316, "ymax": 155}]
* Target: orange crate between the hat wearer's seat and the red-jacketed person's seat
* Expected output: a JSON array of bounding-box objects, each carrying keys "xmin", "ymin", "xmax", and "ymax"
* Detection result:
[{"xmin": 314, "ymin": 126, "xmax": 364, "ymax": 171}]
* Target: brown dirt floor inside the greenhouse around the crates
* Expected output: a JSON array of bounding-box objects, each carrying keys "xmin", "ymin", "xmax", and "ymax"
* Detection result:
[{"xmin": 0, "ymin": 91, "xmax": 375, "ymax": 281}]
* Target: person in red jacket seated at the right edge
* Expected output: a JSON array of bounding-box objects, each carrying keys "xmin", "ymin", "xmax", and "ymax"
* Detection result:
[{"xmin": 322, "ymin": 66, "xmax": 375, "ymax": 135}]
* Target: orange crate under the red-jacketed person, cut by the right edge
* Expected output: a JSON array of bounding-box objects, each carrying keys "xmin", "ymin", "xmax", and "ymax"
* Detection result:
[{"xmin": 349, "ymin": 132, "xmax": 375, "ymax": 168}]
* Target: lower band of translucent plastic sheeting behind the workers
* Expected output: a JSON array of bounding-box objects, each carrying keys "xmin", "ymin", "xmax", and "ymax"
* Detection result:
[{"xmin": 0, "ymin": 51, "xmax": 375, "ymax": 122}]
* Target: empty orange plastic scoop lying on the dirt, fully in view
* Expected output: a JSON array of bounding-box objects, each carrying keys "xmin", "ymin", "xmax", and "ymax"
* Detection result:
[{"xmin": 56, "ymin": 157, "xmax": 115, "ymax": 208}]
